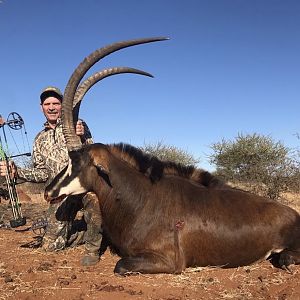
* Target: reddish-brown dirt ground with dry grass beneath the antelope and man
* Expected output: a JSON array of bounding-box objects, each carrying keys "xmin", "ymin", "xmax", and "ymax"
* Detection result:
[{"xmin": 0, "ymin": 191, "xmax": 300, "ymax": 300}]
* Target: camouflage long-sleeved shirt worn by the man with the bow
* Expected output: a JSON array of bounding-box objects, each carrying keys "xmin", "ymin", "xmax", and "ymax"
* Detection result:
[{"xmin": 18, "ymin": 120, "xmax": 93, "ymax": 182}]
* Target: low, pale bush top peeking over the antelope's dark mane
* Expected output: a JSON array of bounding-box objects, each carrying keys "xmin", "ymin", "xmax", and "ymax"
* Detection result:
[{"xmin": 140, "ymin": 142, "xmax": 200, "ymax": 165}]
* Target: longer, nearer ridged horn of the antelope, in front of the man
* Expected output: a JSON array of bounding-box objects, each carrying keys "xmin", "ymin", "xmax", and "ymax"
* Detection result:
[{"xmin": 62, "ymin": 37, "xmax": 168, "ymax": 151}]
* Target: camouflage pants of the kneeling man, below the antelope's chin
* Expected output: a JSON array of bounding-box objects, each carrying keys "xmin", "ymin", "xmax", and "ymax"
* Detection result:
[{"xmin": 43, "ymin": 193, "xmax": 102, "ymax": 254}]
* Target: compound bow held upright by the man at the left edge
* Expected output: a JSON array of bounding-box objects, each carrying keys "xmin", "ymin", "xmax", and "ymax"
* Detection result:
[{"xmin": 0, "ymin": 112, "xmax": 31, "ymax": 228}]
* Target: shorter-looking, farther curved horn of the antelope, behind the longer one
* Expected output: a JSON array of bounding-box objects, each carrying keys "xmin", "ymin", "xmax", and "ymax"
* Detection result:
[{"xmin": 73, "ymin": 67, "xmax": 153, "ymax": 124}]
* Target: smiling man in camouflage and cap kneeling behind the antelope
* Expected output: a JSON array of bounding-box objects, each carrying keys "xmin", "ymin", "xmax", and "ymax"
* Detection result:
[{"xmin": 0, "ymin": 86, "xmax": 102, "ymax": 265}]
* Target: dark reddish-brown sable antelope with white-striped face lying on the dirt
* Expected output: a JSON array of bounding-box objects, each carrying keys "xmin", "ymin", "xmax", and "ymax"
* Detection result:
[{"xmin": 45, "ymin": 39, "xmax": 300, "ymax": 274}]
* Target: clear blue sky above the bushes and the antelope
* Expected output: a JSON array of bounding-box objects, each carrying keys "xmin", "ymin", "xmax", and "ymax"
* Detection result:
[{"xmin": 0, "ymin": 0, "xmax": 300, "ymax": 170}]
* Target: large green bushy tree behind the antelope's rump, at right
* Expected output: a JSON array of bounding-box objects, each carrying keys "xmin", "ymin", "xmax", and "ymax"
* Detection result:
[{"xmin": 210, "ymin": 133, "xmax": 299, "ymax": 199}]
